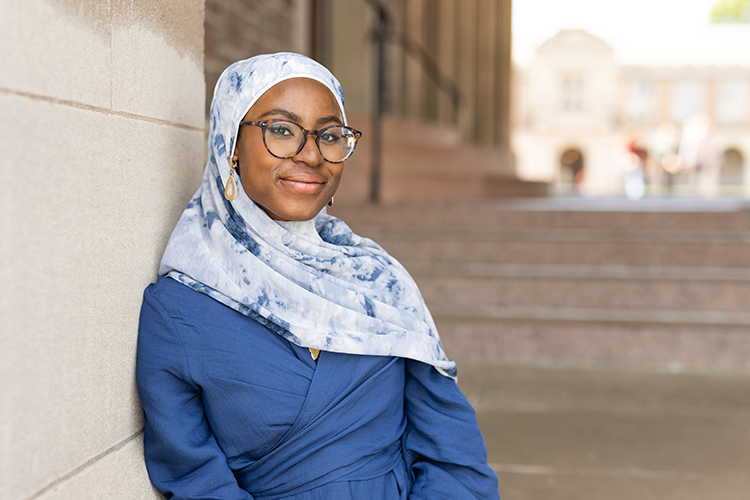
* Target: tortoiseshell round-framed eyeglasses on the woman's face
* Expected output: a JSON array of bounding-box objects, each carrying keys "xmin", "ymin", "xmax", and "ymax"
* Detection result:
[{"xmin": 240, "ymin": 120, "xmax": 362, "ymax": 163}]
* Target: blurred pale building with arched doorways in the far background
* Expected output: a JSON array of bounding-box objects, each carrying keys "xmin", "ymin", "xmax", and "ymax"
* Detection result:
[{"xmin": 512, "ymin": 30, "xmax": 750, "ymax": 198}]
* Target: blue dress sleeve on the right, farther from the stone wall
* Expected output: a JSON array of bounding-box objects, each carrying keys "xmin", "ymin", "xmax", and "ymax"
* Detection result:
[{"xmin": 403, "ymin": 359, "xmax": 500, "ymax": 500}]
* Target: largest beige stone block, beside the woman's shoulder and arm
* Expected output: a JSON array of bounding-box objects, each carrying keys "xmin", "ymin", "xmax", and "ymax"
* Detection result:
[{"xmin": 0, "ymin": 93, "xmax": 204, "ymax": 500}]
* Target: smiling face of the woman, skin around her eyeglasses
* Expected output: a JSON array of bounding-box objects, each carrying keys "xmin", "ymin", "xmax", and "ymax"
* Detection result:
[{"xmin": 232, "ymin": 78, "xmax": 344, "ymax": 221}]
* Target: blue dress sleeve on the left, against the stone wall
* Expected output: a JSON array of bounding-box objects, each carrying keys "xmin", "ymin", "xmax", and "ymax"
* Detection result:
[{"xmin": 136, "ymin": 289, "xmax": 252, "ymax": 500}]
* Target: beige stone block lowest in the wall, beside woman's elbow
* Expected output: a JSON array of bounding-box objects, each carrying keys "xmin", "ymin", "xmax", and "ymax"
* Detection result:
[{"xmin": 35, "ymin": 433, "xmax": 164, "ymax": 500}]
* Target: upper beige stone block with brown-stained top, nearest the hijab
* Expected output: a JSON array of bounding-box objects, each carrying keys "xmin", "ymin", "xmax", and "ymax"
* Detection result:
[{"xmin": 111, "ymin": 0, "xmax": 205, "ymax": 127}]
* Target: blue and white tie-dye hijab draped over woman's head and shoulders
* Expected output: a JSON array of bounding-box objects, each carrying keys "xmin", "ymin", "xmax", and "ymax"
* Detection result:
[{"xmin": 159, "ymin": 53, "xmax": 456, "ymax": 378}]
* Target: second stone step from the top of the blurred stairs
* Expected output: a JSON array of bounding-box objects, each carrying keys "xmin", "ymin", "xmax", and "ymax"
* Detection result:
[{"xmin": 378, "ymin": 234, "xmax": 750, "ymax": 269}]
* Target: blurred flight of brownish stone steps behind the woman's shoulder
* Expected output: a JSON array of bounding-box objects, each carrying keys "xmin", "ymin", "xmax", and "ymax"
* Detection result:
[{"xmin": 331, "ymin": 199, "xmax": 750, "ymax": 372}]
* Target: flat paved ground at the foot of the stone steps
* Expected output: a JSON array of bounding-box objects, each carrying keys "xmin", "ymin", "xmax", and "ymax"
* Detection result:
[{"xmin": 459, "ymin": 360, "xmax": 750, "ymax": 500}]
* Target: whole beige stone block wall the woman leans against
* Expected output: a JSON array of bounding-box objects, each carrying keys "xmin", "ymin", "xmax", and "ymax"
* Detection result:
[{"xmin": 0, "ymin": 0, "xmax": 205, "ymax": 500}]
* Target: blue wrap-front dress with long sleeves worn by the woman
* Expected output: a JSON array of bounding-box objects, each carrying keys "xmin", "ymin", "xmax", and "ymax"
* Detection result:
[{"xmin": 137, "ymin": 278, "xmax": 499, "ymax": 500}]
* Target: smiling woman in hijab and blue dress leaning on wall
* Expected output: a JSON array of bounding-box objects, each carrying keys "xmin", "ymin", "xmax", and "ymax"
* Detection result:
[{"xmin": 137, "ymin": 53, "xmax": 498, "ymax": 500}]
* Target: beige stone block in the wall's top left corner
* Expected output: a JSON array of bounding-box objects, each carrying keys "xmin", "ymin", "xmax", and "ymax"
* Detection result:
[{"xmin": 0, "ymin": 0, "xmax": 111, "ymax": 108}]
